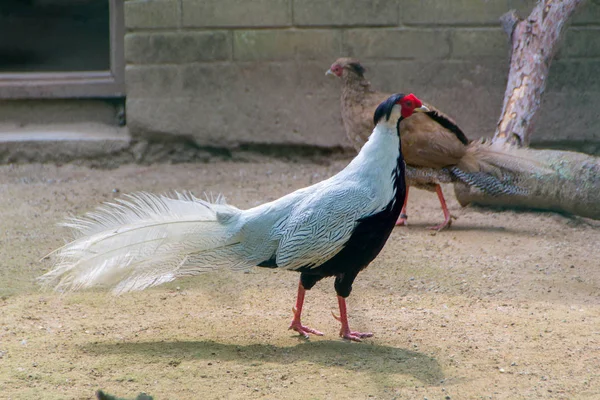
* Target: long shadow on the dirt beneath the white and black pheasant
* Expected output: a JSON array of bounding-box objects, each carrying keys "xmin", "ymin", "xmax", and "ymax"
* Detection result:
[{"xmin": 84, "ymin": 340, "xmax": 444, "ymax": 385}]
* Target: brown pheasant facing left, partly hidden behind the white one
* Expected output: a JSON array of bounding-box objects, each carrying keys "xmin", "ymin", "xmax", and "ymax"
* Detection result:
[{"xmin": 327, "ymin": 58, "xmax": 527, "ymax": 231}]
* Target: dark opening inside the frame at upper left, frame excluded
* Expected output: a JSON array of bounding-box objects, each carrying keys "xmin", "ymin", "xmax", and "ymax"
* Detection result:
[{"xmin": 0, "ymin": 0, "xmax": 110, "ymax": 72}]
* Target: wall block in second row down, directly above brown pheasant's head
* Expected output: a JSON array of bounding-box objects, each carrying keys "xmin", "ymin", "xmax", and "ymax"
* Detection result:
[{"xmin": 344, "ymin": 29, "xmax": 450, "ymax": 60}]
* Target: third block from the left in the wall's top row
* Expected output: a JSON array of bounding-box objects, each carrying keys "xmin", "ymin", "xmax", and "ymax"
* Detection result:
[{"xmin": 293, "ymin": 0, "xmax": 398, "ymax": 26}]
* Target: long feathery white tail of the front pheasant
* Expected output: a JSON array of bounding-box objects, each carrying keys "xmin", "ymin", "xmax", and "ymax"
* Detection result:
[{"xmin": 40, "ymin": 193, "xmax": 252, "ymax": 294}]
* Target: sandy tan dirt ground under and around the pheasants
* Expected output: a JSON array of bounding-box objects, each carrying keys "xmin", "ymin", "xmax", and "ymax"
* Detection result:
[{"xmin": 0, "ymin": 161, "xmax": 600, "ymax": 400}]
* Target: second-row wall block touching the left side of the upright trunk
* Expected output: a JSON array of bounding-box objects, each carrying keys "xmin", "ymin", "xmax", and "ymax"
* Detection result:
[{"xmin": 449, "ymin": 28, "xmax": 510, "ymax": 59}]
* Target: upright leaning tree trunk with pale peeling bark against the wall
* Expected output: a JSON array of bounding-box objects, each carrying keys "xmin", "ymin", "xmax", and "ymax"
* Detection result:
[{"xmin": 493, "ymin": 0, "xmax": 584, "ymax": 146}]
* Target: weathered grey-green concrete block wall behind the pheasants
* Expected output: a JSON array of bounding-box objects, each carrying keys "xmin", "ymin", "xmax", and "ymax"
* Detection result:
[{"xmin": 125, "ymin": 0, "xmax": 600, "ymax": 148}]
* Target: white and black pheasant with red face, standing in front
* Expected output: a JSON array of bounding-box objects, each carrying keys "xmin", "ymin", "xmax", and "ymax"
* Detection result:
[{"xmin": 40, "ymin": 94, "xmax": 427, "ymax": 341}]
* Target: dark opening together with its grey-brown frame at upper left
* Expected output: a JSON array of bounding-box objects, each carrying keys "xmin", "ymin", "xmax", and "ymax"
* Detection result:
[{"xmin": 0, "ymin": 0, "xmax": 125, "ymax": 99}]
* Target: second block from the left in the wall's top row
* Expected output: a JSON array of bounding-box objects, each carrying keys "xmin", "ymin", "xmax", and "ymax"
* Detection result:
[{"xmin": 182, "ymin": 0, "xmax": 291, "ymax": 27}]
